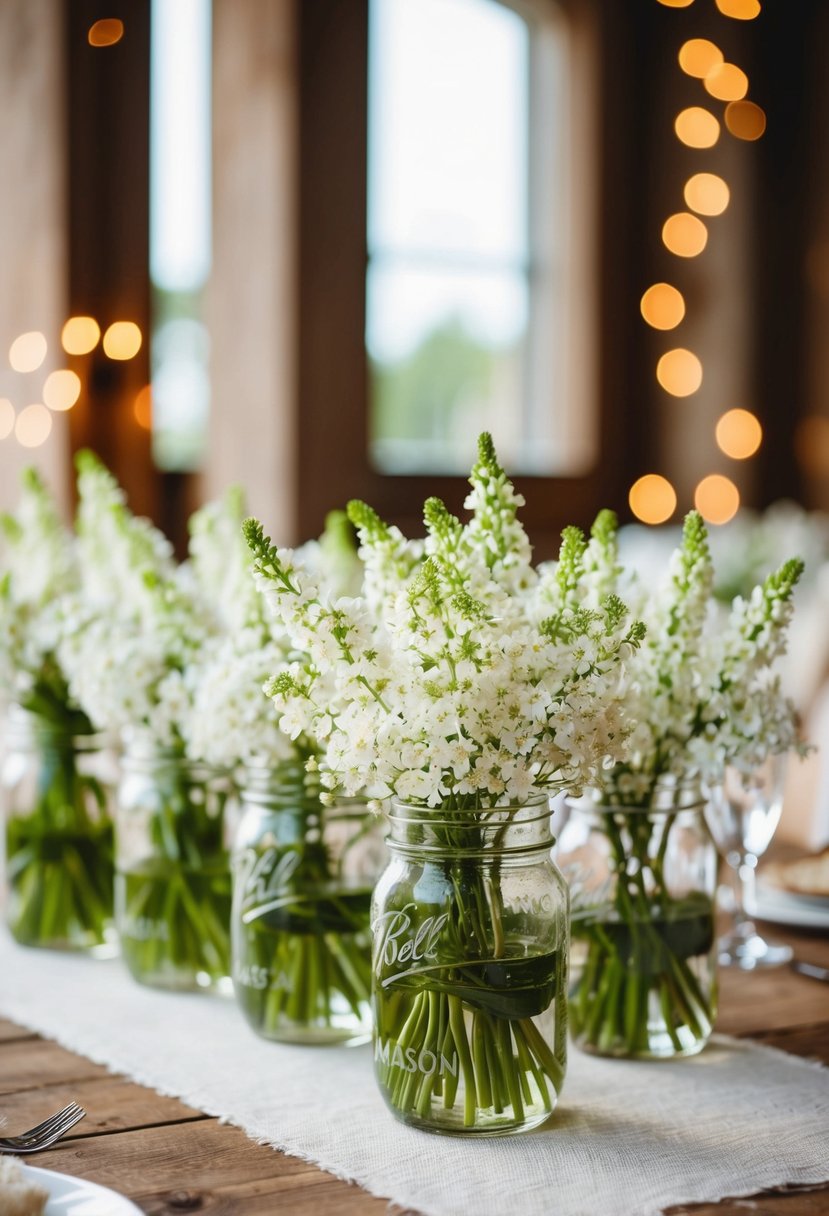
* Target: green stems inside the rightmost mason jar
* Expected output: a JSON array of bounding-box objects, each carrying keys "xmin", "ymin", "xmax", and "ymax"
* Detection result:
[{"xmin": 570, "ymin": 809, "xmax": 716, "ymax": 1057}]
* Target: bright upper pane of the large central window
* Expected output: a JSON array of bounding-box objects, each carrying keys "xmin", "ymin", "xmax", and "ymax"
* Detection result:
[{"xmin": 368, "ymin": 0, "xmax": 529, "ymax": 260}]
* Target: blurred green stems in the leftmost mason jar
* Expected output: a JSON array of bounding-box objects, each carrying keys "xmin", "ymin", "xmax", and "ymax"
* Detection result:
[{"xmin": 6, "ymin": 721, "xmax": 113, "ymax": 950}]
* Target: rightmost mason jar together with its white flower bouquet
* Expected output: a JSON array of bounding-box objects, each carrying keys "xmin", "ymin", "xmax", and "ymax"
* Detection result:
[{"xmin": 559, "ymin": 512, "xmax": 802, "ymax": 1055}]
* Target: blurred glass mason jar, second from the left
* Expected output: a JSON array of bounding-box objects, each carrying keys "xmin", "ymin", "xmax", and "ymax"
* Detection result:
[{"xmin": 115, "ymin": 748, "xmax": 231, "ymax": 992}]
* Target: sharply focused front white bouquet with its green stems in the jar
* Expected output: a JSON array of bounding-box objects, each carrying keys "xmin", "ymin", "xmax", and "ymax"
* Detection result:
[{"xmin": 246, "ymin": 435, "xmax": 642, "ymax": 1131}]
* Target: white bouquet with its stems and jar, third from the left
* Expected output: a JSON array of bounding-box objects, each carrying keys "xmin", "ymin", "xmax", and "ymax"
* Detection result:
[{"xmin": 188, "ymin": 498, "xmax": 383, "ymax": 1042}]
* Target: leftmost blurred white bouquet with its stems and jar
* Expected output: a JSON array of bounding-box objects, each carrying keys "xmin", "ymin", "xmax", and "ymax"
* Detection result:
[{"xmin": 0, "ymin": 469, "xmax": 113, "ymax": 950}]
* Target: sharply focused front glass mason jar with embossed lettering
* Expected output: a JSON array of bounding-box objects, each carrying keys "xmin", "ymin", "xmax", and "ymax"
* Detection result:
[{"xmin": 372, "ymin": 798, "xmax": 568, "ymax": 1136}]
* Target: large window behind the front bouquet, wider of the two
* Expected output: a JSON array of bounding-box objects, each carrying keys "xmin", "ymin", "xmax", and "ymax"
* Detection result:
[{"xmin": 366, "ymin": 0, "xmax": 594, "ymax": 475}]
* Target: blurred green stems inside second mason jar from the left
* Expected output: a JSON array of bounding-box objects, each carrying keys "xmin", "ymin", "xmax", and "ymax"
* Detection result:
[{"xmin": 115, "ymin": 760, "xmax": 231, "ymax": 989}]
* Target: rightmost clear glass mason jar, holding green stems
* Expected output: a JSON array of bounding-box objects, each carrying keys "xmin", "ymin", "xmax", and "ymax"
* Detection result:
[{"xmin": 557, "ymin": 784, "xmax": 717, "ymax": 1059}]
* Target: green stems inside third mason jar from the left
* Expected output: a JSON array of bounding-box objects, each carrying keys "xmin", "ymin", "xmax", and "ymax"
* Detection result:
[{"xmin": 232, "ymin": 801, "xmax": 376, "ymax": 1042}]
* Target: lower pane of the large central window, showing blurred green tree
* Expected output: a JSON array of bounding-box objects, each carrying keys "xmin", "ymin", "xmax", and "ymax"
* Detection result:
[{"xmin": 367, "ymin": 259, "xmax": 538, "ymax": 473}]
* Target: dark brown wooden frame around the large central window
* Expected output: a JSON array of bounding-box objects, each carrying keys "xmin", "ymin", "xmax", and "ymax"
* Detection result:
[{"xmin": 297, "ymin": 0, "xmax": 621, "ymax": 556}]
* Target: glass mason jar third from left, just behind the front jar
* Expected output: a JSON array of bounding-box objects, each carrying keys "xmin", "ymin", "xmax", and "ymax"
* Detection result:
[{"xmin": 232, "ymin": 764, "xmax": 387, "ymax": 1043}]
